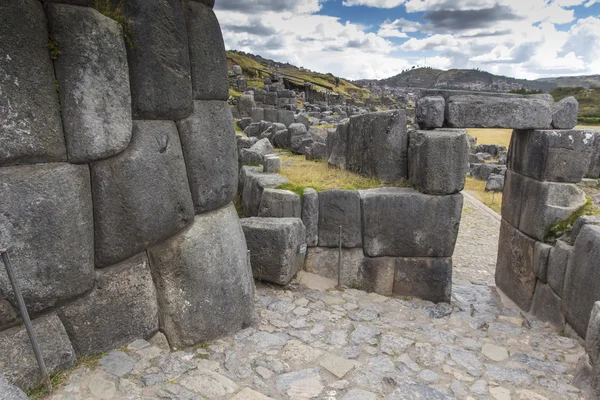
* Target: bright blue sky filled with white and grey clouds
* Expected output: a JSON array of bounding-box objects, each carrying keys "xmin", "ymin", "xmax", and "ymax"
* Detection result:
[{"xmin": 215, "ymin": 0, "xmax": 600, "ymax": 79}]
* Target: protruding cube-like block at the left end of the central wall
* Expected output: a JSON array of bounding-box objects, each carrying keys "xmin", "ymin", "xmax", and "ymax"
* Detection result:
[{"xmin": 241, "ymin": 218, "xmax": 306, "ymax": 285}]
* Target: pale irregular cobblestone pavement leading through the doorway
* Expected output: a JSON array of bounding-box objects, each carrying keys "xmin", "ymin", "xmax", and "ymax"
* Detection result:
[{"xmin": 45, "ymin": 197, "xmax": 583, "ymax": 400}]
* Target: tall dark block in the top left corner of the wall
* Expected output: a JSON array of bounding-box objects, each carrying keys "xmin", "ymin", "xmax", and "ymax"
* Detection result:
[{"xmin": 0, "ymin": 0, "xmax": 67, "ymax": 166}]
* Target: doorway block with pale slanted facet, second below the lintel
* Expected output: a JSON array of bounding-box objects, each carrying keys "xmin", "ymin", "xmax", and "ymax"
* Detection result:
[{"xmin": 519, "ymin": 177, "xmax": 587, "ymax": 242}]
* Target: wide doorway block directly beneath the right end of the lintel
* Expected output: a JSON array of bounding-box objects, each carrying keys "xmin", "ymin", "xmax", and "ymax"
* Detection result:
[{"xmin": 507, "ymin": 130, "xmax": 595, "ymax": 183}]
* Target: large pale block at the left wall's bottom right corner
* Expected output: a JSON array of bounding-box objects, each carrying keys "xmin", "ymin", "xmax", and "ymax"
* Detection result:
[{"xmin": 148, "ymin": 205, "xmax": 254, "ymax": 347}]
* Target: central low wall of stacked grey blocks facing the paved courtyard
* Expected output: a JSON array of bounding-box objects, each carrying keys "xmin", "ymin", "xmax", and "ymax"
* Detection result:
[{"xmin": 240, "ymin": 110, "xmax": 468, "ymax": 302}]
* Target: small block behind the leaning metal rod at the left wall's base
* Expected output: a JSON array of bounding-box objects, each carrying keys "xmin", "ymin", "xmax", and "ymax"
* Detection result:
[{"xmin": 0, "ymin": 313, "xmax": 76, "ymax": 395}]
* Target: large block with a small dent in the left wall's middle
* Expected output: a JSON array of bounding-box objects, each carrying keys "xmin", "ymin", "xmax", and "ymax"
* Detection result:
[{"xmin": 91, "ymin": 121, "xmax": 194, "ymax": 267}]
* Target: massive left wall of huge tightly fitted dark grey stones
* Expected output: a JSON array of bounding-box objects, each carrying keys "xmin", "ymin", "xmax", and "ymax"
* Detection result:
[{"xmin": 0, "ymin": 0, "xmax": 254, "ymax": 388}]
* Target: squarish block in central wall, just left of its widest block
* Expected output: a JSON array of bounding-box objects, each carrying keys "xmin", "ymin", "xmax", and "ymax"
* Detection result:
[{"xmin": 319, "ymin": 190, "xmax": 362, "ymax": 248}]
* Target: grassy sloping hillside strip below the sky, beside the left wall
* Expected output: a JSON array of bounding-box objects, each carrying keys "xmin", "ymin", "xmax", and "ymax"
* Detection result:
[{"xmin": 227, "ymin": 50, "xmax": 371, "ymax": 103}]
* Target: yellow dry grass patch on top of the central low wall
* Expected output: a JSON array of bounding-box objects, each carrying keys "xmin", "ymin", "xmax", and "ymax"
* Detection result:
[{"xmin": 279, "ymin": 153, "xmax": 407, "ymax": 192}]
